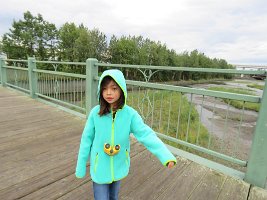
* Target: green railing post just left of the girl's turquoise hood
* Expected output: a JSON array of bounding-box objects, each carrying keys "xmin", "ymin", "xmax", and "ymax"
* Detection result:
[{"xmin": 85, "ymin": 58, "xmax": 98, "ymax": 117}]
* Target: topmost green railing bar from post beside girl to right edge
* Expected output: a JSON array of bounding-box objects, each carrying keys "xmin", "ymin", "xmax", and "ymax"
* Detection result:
[{"xmin": 95, "ymin": 63, "xmax": 267, "ymax": 75}]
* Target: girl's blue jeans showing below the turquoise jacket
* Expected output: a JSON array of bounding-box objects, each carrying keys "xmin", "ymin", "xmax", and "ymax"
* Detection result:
[{"xmin": 93, "ymin": 181, "xmax": 120, "ymax": 200}]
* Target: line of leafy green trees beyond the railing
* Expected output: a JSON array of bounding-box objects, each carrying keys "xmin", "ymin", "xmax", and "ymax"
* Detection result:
[{"xmin": 0, "ymin": 11, "xmax": 232, "ymax": 81}]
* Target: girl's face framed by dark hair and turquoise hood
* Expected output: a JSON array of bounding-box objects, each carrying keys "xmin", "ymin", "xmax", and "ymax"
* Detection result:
[{"xmin": 102, "ymin": 80, "xmax": 121, "ymax": 108}]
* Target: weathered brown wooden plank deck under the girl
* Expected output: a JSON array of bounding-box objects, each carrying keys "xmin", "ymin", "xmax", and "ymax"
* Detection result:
[{"xmin": 0, "ymin": 86, "xmax": 267, "ymax": 200}]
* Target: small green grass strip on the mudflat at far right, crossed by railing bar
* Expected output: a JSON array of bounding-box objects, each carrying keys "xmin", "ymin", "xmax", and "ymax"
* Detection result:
[{"xmin": 208, "ymin": 87, "xmax": 260, "ymax": 112}]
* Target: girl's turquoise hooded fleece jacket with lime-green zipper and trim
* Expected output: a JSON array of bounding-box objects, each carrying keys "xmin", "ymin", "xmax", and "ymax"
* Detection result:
[{"xmin": 75, "ymin": 70, "xmax": 176, "ymax": 184}]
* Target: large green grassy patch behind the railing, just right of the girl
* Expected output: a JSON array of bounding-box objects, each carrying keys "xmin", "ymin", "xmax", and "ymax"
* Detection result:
[{"xmin": 128, "ymin": 90, "xmax": 211, "ymax": 149}]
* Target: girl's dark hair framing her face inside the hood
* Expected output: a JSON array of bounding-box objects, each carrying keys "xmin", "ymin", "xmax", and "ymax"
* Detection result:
[{"xmin": 98, "ymin": 76, "xmax": 125, "ymax": 116}]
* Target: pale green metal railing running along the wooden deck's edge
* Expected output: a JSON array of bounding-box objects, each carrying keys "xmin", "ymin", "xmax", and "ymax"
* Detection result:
[{"xmin": 0, "ymin": 58, "xmax": 267, "ymax": 187}]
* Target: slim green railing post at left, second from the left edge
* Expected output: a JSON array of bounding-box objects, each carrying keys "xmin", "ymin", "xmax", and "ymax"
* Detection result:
[{"xmin": 28, "ymin": 58, "xmax": 37, "ymax": 99}]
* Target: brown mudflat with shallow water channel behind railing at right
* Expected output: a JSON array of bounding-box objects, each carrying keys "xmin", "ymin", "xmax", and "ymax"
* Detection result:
[{"xmin": 188, "ymin": 80, "xmax": 264, "ymax": 169}]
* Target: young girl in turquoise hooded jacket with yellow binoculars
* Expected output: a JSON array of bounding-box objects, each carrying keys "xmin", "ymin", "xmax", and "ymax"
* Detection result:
[{"xmin": 76, "ymin": 70, "xmax": 176, "ymax": 200}]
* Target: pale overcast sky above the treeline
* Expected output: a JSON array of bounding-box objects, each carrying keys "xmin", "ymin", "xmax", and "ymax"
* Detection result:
[{"xmin": 0, "ymin": 0, "xmax": 267, "ymax": 66}]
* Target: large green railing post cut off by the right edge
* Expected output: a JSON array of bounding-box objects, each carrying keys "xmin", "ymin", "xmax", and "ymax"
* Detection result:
[{"xmin": 245, "ymin": 78, "xmax": 267, "ymax": 188}]
